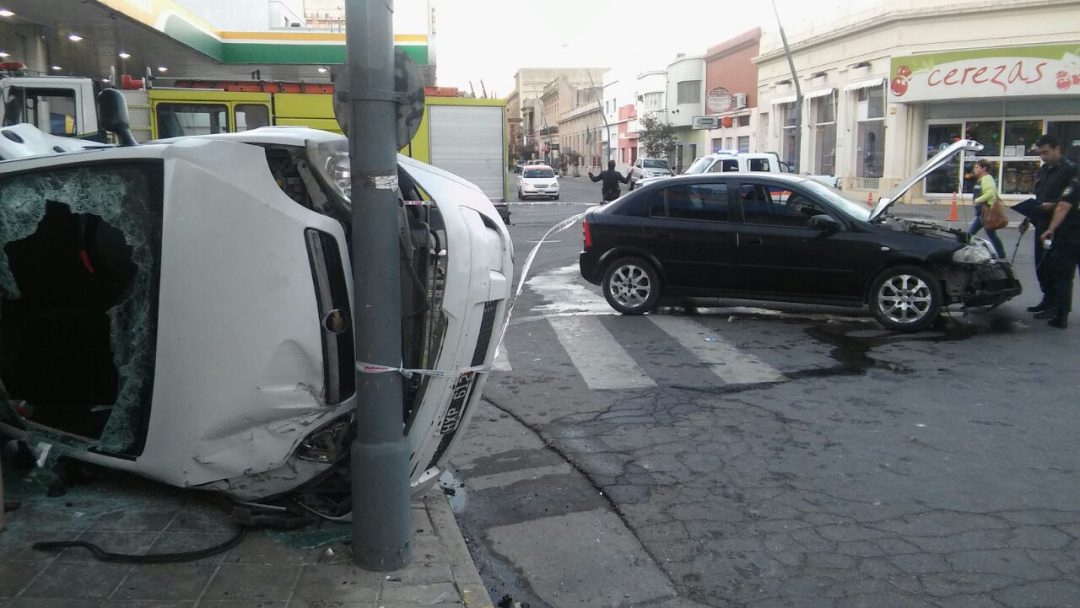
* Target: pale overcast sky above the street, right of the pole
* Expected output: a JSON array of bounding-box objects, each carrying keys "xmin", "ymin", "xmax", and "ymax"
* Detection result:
[{"xmin": 434, "ymin": 0, "xmax": 882, "ymax": 97}]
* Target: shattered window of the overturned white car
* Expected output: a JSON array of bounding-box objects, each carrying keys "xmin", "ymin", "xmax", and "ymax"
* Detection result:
[{"xmin": 0, "ymin": 162, "xmax": 162, "ymax": 454}]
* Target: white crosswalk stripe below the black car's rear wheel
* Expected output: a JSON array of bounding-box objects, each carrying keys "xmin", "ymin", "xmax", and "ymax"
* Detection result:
[{"xmin": 548, "ymin": 315, "xmax": 657, "ymax": 390}]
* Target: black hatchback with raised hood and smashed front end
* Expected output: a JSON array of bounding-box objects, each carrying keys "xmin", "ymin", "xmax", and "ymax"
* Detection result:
[{"xmin": 580, "ymin": 140, "xmax": 1021, "ymax": 332}]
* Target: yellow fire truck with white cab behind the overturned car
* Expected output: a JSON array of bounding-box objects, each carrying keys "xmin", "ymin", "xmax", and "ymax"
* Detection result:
[{"xmin": 0, "ymin": 66, "xmax": 509, "ymax": 203}]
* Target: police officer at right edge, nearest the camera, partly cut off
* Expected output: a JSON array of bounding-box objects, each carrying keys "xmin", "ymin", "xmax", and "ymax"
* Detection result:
[{"xmin": 1036, "ymin": 136, "xmax": 1080, "ymax": 329}]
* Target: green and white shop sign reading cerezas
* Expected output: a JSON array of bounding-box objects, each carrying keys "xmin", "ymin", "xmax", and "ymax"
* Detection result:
[{"xmin": 889, "ymin": 44, "xmax": 1080, "ymax": 103}]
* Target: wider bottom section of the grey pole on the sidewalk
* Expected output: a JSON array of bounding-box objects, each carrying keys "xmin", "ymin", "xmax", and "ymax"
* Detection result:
[{"xmin": 351, "ymin": 440, "xmax": 413, "ymax": 572}]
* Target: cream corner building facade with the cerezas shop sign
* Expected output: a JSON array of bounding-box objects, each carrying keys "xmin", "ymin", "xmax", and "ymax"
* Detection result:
[{"xmin": 755, "ymin": 0, "xmax": 1080, "ymax": 201}]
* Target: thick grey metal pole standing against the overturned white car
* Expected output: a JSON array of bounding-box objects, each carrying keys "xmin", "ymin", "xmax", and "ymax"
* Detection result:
[{"xmin": 346, "ymin": 0, "xmax": 413, "ymax": 572}]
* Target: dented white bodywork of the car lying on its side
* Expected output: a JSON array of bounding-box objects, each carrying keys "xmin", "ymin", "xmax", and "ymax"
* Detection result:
[{"xmin": 0, "ymin": 129, "xmax": 513, "ymax": 500}]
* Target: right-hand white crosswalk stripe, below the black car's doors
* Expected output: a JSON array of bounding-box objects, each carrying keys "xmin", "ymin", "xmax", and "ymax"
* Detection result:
[{"xmin": 647, "ymin": 314, "xmax": 785, "ymax": 384}]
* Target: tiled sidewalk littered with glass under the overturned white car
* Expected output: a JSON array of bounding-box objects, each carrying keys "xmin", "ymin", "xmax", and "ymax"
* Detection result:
[{"xmin": 0, "ymin": 463, "xmax": 491, "ymax": 608}]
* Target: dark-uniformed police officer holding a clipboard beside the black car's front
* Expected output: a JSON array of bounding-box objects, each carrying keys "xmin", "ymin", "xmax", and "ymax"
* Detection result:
[{"xmin": 1020, "ymin": 134, "xmax": 1077, "ymax": 319}]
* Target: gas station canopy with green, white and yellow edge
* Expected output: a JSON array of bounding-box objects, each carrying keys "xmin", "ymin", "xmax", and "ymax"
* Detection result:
[{"xmin": 0, "ymin": 0, "xmax": 429, "ymax": 82}]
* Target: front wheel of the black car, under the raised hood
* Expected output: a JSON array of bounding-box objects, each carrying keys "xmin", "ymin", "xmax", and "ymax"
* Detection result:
[{"xmin": 869, "ymin": 266, "xmax": 942, "ymax": 332}]
